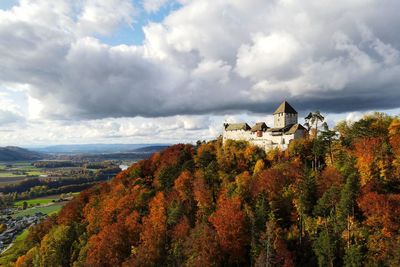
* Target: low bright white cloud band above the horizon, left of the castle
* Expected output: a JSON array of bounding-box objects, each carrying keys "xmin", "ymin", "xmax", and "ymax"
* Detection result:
[{"xmin": 0, "ymin": 114, "xmax": 216, "ymax": 146}]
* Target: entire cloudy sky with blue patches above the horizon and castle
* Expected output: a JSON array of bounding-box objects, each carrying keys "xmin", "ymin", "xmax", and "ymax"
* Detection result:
[{"xmin": 0, "ymin": 0, "xmax": 400, "ymax": 146}]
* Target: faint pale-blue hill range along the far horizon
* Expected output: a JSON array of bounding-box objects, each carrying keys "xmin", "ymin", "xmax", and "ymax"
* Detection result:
[{"xmin": 31, "ymin": 144, "xmax": 170, "ymax": 154}]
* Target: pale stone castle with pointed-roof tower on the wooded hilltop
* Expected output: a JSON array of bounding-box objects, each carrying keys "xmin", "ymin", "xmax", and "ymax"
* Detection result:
[{"xmin": 222, "ymin": 101, "xmax": 307, "ymax": 151}]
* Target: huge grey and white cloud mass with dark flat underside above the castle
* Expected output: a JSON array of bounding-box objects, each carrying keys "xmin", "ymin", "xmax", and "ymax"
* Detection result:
[{"xmin": 0, "ymin": 0, "xmax": 400, "ymax": 119}]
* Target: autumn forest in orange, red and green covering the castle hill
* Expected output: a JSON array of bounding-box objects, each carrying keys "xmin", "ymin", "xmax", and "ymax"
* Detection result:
[{"xmin": 10, "ymin": 113, "xmax": 400, "ymax": 267}]
